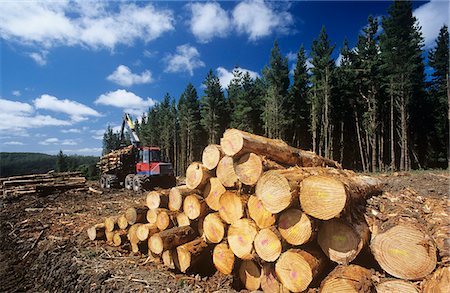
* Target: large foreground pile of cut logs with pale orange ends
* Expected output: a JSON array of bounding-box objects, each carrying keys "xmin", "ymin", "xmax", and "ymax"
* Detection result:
[{"xmin": 88, "ymin": 129, "xmax": 450, "ymax": 292}]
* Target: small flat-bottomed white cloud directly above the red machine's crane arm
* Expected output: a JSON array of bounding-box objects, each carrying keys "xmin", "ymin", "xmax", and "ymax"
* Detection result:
[{"xmin": 94, "ymin": 89, "xmax": 156, "ymax": 114}]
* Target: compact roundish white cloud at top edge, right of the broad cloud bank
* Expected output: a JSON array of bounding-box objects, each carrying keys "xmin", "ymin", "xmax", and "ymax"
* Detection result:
[{"xmin": 188, "ymin": 2, "xmax": 232, "ymax": 43}]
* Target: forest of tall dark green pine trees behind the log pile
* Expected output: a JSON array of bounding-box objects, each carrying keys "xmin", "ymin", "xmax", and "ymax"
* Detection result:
[{"xmin": 104, "ymin": 1, "xmax": 450, "ymax": 175}]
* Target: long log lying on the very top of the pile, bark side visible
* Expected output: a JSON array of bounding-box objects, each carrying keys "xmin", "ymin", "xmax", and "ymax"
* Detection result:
[{"xmin": 220, "ymin": 129, "xmax": 341, "ymax": 168}]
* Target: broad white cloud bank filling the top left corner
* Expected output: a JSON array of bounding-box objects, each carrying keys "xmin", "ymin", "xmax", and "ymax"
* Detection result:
[{"xmin": 0, "ymin": 0, "xmax": 174, "ymax": 49}]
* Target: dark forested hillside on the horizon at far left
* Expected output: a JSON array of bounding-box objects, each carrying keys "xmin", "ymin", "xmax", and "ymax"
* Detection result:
[{"xmin": 0, "ymin": 153, "xmax": 99, "ymax": 179}]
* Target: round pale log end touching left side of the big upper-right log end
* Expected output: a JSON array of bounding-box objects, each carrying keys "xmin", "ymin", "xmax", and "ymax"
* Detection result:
[{"xmin": 255, "ymin": 171, "xmax": 292, "ymax": 214}]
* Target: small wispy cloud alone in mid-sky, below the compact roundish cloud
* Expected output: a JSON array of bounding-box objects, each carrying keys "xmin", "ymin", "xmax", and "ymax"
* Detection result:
[{"xmin": 166, "ymin": 44, "xmax": 205, "ymax": 76}]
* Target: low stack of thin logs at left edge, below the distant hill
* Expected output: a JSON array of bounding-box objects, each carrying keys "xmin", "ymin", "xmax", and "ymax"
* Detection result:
[{"xmin": 0, "ymin": 172, "xmax": 87, "ymax": 198}]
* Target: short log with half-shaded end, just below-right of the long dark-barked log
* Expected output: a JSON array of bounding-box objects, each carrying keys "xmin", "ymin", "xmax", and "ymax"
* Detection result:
[{"xmin": 175, "ymin": 237, "xmax": 209, "ymax": 273}]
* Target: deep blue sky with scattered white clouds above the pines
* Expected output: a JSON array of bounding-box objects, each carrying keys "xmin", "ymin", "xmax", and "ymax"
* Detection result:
[{"xmin": 0, "ymin": 0, "xmax": 449, "ymax": 155}]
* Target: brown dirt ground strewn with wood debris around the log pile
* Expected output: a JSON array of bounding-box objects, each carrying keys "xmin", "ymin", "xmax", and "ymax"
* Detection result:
[{"xmin": 0, "ymin": 171, "xmax": 450, "ymax": 292}]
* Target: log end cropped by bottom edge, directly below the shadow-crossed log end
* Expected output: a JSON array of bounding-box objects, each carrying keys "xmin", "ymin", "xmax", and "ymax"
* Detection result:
[{"xmin": 320, "ymin": 265, "xmax": 374, "ymax": 293}]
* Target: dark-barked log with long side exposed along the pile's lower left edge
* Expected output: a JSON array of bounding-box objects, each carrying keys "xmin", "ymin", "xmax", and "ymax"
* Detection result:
[{"xmin": 148, "ymin": 226, "xmax": 197, "ymax": 254}]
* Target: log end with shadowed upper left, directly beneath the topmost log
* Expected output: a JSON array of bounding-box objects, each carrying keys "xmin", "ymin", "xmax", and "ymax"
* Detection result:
[{"xmin": 234, "ymin": 153, "xmax": 263, "ymax": 186}]
